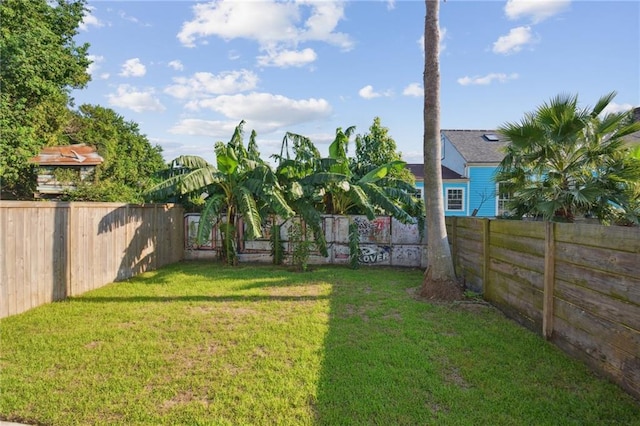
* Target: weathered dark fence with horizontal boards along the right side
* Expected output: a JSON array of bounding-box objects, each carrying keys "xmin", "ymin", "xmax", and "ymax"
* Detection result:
[{"xmin": 447, "ymin": 218, "xmax": 640, "ymax": 398}]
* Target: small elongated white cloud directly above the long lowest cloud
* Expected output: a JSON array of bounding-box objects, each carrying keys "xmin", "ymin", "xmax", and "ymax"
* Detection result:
[{"xmin": 164, "ymin": 70, "xmax": 258, "ymax": 99}]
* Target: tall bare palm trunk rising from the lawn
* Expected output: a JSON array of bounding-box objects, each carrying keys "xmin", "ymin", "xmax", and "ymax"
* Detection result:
[{"xmin": 421, "ymin": 0, "xmax": 457, "ymax": 298}]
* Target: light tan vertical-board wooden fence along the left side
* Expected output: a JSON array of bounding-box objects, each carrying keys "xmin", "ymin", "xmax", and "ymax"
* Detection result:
[{"xmin": 0, "ymin": 201, "xmax": 184, "ymax": 318}]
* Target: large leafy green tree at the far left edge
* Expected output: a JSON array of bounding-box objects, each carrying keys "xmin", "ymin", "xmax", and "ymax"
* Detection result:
[{"xmin": 0, "ymin": 0, "xmax": 90, "ymax": 198}]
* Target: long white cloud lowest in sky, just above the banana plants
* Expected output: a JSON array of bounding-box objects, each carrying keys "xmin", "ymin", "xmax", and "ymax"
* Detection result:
[{"xmin": 186, "ymin": 92, "xmax": 331, "ymax": 131}]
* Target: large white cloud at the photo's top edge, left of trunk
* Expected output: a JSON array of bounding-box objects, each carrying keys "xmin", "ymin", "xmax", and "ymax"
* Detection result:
[{"xmin": 177, "ymin": 0, "xmax": 353, "ymax": 50}]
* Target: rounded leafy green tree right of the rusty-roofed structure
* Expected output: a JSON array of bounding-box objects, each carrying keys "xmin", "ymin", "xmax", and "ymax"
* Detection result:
[{"xmin": 65, "ymin": 104, "xmax": 167, "ymax": 202}]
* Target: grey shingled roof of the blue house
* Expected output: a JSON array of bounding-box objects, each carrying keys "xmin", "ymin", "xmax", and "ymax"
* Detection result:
[{"xmin": 442, "ymin": 130, "xmax": 508, "ymax": 163}]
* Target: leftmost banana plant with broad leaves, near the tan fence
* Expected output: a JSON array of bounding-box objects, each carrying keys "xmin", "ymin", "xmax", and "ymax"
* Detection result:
[{"xmin": 147, "ymin": 120, "xmax": 294, "ymax": 264}]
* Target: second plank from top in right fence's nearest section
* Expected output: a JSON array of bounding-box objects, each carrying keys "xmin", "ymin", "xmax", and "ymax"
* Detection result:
[{"xmin": 556, "ymin": 242, "xmax": 640, "ymax": 278}]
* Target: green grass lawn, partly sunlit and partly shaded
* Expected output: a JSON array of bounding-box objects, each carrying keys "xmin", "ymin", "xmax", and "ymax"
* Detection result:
[{"xmin": 0, "ymin": 263, "xmax": 640, "ymax": 425}]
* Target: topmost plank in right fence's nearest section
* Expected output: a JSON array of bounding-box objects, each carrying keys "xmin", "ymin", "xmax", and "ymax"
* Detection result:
[{"xmin": 556, "ymin": 223, "xmax": 640, "ymax": 253}]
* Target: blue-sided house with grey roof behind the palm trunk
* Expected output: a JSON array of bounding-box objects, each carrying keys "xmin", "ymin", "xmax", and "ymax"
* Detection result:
[{"xmin": 407, "ymin": 130, "xmax": 508, "ymax": 217}]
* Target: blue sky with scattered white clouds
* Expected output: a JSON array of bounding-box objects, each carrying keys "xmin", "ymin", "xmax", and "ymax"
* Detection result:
[{"xmin": 73, "ymin": 0, "xmax": 640, "ymax": 164}]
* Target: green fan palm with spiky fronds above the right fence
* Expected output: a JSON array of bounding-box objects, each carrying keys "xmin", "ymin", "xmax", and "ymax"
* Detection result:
[{"xmin": 496, "ymin": 92, "xmax": 640, "ymax": 223}]
